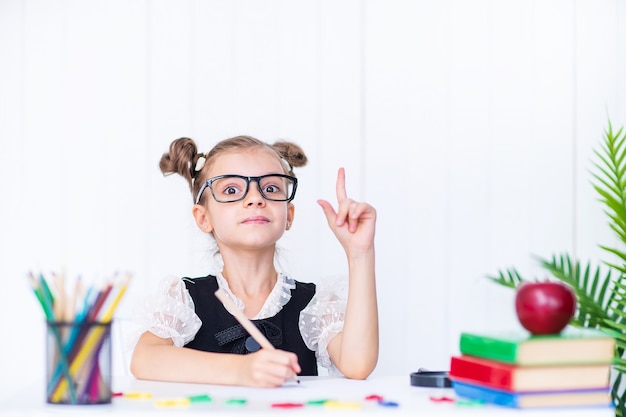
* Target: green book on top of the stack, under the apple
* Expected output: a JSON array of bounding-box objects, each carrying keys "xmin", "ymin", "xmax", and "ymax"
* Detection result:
[{"xmin": 460, "ymin": 326, "xmax": 615, "ymax": 365}]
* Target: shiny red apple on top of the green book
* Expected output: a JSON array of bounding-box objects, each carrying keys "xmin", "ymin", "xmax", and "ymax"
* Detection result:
[{"xmin": 515, "ymin": 281, "xmax": 576, "ymax": 335}]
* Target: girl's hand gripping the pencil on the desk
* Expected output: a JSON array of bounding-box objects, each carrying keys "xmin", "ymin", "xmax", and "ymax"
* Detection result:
[{"xmin": 241, "ymin": 349, "xmax": 301, "ymax": 388}]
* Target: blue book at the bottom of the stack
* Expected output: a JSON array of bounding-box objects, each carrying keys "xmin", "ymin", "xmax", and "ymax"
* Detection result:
[{"xmin": 452, "ymin": 381, "xmax": 613, "ymax": 408}]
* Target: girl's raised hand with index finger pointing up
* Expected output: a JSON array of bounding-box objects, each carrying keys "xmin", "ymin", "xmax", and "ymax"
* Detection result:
[{"xmin": 317, "ymin": 168, "xmax": 376, "ymax": 254}]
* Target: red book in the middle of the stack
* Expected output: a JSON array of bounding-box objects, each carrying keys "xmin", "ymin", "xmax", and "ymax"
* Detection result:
[{"xmin": 449, "ymin": 355, "xmax": 610, "ymax": 392}]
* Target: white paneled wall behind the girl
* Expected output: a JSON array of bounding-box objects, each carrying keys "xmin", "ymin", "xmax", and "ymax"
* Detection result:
[{"xmin": 0, "ymin": 0, "xmax": 626, "ymax": 404}]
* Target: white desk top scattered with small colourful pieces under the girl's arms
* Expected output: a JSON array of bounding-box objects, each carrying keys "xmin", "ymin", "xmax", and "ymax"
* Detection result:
[{"xmin": 0, "ymin": 375, "xmax": 615, "ymax": 417}]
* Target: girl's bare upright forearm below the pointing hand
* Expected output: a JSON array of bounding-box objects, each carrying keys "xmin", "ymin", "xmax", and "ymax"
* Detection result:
[{"xmin": 328, "ymin": 248, "xmax": 378, "ymax": 379}]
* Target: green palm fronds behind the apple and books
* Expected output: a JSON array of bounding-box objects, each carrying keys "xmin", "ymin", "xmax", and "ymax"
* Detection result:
[{"xmin": 487, "ymin": 121, "xmax": 626, "ymax": 417}]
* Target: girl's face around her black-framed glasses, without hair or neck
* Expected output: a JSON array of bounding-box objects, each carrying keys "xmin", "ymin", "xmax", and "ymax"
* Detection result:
[{"xmin": 203, "ymin": 149, "xmax": 294, "ymax": 250}]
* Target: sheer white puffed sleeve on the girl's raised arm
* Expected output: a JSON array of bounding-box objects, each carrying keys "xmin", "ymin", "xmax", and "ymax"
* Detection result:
[{"xmin": 299, "ymin": 278, "xmax": 347, "ymax": 375}]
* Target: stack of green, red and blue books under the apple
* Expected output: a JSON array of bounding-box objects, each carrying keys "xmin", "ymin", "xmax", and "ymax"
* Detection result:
[{"xmin": 449, "ymin": 327, "xmax": 615, "ymax": 408}]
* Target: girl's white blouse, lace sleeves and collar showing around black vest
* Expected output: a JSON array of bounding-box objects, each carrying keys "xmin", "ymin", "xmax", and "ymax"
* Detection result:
[{"xmin": 137, "ymin": 273, "xmax": 347, "ymax": 375}]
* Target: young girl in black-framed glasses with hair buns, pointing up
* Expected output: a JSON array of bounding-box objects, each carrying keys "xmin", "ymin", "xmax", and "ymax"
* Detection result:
[{"xmin": 131, "ymin": 136, "xmax": 378, "ymax": 387}]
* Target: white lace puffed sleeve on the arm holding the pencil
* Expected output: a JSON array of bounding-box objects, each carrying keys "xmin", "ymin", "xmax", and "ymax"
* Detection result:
[{"xmin": 137, "ymin": 277, "xmax": 202, "ymax": 347}]
